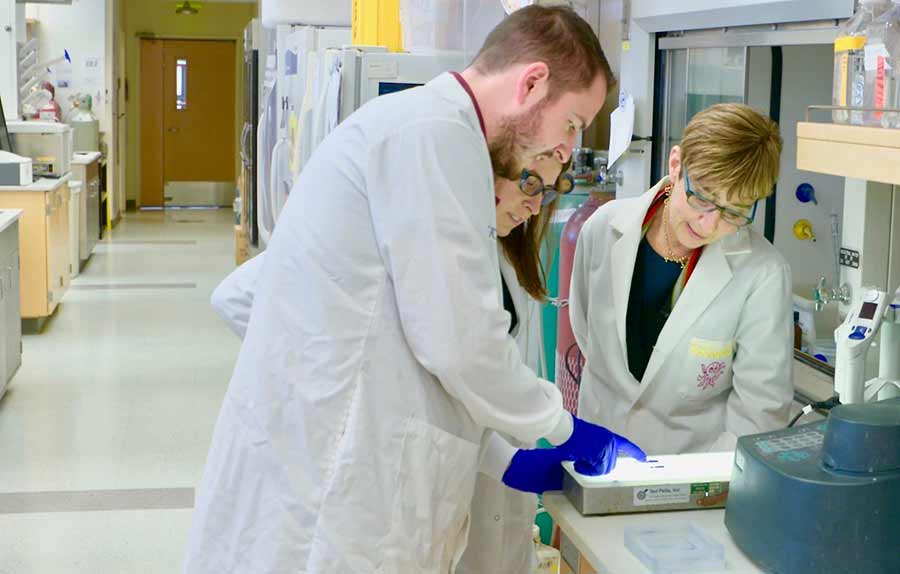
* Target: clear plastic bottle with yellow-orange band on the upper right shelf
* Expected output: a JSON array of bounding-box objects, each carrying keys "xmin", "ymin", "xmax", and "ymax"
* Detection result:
[{"xmin": 832, "ymin": 0, "xmax": 891, "ymax": 124}]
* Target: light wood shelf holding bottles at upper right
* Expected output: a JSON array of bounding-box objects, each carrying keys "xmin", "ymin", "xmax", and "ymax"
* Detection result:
[{"xmin": 797, "ymin": 121, "xmax": 900, "ymax": 185}]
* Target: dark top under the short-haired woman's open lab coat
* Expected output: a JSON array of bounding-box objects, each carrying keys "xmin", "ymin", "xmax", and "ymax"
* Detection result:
[{"xmin": 625, "ymin": 237, "xmax": 681, "ymax": 381}]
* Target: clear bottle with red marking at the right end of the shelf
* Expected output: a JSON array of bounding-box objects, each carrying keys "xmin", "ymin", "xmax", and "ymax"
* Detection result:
[{"xmin": 864, "ymin": 0, "xmax": 900, "ymax": 127}]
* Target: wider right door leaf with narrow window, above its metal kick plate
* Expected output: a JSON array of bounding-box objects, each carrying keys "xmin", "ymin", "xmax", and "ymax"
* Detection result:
[{"xmin": 164, "ymin": 40, "xmax": 236, "ymax": 182}]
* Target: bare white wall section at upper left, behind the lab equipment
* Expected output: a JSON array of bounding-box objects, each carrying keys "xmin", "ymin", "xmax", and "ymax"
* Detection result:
[{"xmin": 26, "ymin": 0, "xmax": 111, "ymax": 132}]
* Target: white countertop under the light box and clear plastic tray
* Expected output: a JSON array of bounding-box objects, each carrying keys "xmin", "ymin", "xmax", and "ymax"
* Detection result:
[{"xmin": 544, "ymin": 492, "xmax": 763, "ymax": 574}]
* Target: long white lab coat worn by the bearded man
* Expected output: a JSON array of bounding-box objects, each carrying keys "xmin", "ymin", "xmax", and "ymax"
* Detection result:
[{"xmin": 184, "ymin": 74, "xmax": 572, "ymax": 574}]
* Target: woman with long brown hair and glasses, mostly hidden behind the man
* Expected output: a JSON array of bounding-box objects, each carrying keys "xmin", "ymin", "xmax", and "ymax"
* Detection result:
[{"xmin": 210, "ymin": 157, "xmax": 572, "ymax": 574}]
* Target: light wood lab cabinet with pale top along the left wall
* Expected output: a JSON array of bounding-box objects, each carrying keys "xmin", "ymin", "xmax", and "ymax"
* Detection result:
[{"xmin": 0, "ymin": 175, "xmax": 71, "ymax": 320}]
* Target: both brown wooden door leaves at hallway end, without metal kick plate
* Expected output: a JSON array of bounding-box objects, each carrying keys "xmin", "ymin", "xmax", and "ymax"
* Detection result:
[{"xmin": 140, "ymin": 38, "xmax": 237, "ymax": 207}]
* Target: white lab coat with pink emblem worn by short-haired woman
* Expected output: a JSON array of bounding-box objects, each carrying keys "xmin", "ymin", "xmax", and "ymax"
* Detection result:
[{"xmin": 569, "ymin": 180, "xmax": 793, "ymax": 454}]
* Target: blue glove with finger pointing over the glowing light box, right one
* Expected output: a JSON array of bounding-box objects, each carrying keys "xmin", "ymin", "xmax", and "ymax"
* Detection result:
[{"xmin": 557, "ymin": 417, "xmax": 647, "ymax": 476}]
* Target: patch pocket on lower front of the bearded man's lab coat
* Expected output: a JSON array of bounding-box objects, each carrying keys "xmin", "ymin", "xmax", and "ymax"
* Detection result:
[{"xmin": 383, "ymin": 417, "xmax": 479, "ymax": 574}]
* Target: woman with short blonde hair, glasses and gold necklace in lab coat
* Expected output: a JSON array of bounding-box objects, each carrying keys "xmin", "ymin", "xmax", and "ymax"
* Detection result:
[{"xmin": 569, "ymin": 104, "xmax": 793, "ymax": 464}]
